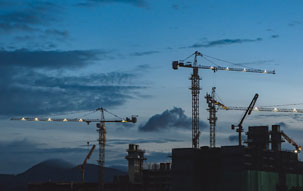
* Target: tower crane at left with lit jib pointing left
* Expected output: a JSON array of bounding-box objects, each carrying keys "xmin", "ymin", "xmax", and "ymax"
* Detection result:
[{"xmin": 11, "ymin": 107, "xmax": 137, "ymax": 191}]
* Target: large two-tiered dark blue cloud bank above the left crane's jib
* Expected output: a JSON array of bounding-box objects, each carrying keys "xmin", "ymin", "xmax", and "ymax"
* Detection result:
[{"xmin": 0, "ymin": 50, "xmax": 144, "ymax": 116}]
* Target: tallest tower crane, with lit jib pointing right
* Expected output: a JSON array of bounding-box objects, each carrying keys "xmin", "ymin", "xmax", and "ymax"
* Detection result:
[{"xmin": 172, "ymin": 51, "xmax": 275, "ymax": 148}]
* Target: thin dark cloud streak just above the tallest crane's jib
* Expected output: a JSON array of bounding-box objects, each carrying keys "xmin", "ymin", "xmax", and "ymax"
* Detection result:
[{"xmin": 188, "ymin": 38, "xmax": 263, "ymax": 48}]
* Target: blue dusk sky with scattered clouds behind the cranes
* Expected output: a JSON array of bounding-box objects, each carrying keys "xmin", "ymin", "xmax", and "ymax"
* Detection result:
[{"xmin": 0, "ymin": 0, "xmax": 303, "ymax": 174}]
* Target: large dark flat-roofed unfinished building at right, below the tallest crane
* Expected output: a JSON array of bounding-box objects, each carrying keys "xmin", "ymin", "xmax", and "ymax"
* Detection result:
[{"xmin": 172, "ymin": 125, "xmax": 303, "ymax": 191}]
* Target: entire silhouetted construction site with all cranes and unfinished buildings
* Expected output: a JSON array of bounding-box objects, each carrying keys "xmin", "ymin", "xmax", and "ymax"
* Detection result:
[{"xmin": 13, "ymin": 51, "xmax": 303, "ymax": 191}]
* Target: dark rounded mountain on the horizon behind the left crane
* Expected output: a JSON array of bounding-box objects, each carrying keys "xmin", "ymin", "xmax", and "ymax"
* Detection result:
[{"xmin": 0, "ymin": 159, "xmax": 126, "ymax": 191}]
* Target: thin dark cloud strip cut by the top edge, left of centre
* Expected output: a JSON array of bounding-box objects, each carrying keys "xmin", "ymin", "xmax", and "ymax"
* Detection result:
[{"xmin": 77, "ymin": 0, "xmax": 148, "ymax": 7}]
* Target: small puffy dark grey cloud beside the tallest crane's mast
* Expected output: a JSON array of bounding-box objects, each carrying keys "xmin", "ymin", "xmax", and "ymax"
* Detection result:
[{"xmin": 139, "ymin": 107, "xmax": 207, "ymax": 132}]
